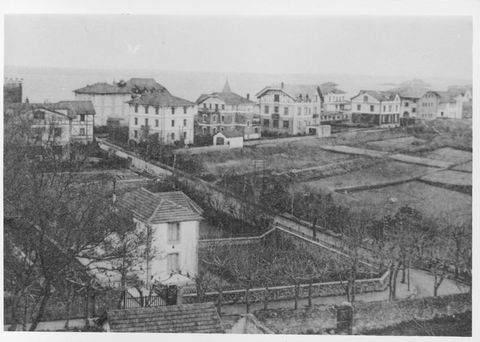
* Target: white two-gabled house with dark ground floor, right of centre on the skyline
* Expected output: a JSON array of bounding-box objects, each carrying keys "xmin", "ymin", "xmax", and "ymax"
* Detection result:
[{"xmin": 351, "ymin": 90, "xmax": 401, "ymax": 127}]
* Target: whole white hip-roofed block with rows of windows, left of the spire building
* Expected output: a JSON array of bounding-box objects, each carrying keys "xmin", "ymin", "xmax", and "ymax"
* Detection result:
[{"xmin": 128, "ymin": 89, "xmax": 196, "ymax": 145}]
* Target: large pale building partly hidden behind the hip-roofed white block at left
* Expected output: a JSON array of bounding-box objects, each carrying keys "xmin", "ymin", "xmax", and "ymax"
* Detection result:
[{"xmin": 73, "ymin": 78, "xmax": 171, "ymax": 126}]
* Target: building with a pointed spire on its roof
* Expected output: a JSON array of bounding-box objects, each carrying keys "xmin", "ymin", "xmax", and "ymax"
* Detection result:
[{"xmin": 195, "ymin": 79, "xmax": 261, "ymax": 143}]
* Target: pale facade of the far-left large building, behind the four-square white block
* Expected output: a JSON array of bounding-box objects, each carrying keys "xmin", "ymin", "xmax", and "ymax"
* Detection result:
[{"xmin": 75, "ymin": 93, "xmax": 131, "ymax": 127}]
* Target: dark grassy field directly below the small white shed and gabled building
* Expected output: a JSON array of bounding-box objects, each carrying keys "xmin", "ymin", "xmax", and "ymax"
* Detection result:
[{"xmin": 199, "ymin": 139, "xmax": 353, "ymax": 176}]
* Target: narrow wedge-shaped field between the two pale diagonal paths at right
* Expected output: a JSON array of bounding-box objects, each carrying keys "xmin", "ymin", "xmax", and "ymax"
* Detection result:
[{"xmin": 302, "ymin": 160, "xmax": 435, "ymax": 189}]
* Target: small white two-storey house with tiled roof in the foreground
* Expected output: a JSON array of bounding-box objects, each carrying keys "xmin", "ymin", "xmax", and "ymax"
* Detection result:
[{"xmin": 118, "ymin": 188, "xmax": 203, "ymax": 287}]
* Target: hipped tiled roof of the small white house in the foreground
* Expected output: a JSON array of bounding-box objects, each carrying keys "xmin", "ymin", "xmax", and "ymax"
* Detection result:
[{"xmin": 118, "ymin": 188, "xmax": 203, "ymax": 224}]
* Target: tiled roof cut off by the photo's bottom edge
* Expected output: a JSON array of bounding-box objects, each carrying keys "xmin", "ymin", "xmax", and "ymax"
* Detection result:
[{"xmin": 107, "ymin": 303, "xmax": 225, "ymax": 334}]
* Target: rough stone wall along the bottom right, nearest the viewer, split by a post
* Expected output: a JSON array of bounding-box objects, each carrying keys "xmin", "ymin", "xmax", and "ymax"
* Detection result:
[{"xmin": 254, "ymin": 293, "xmax": 472, "ymax": 334}]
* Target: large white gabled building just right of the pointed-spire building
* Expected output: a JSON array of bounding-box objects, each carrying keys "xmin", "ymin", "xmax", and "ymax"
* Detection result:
[{"xmin": 256, "ymin": 82, "xmax": 322, "ymax": 135}]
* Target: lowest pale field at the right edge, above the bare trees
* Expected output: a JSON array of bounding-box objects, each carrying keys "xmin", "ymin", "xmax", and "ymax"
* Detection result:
[{"xmin": 349, "ymin": 181, "xmax": 472, "ymax": 218}]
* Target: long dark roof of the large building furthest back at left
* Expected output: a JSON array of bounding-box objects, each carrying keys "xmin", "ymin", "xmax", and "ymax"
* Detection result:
[{"xmin": 73, "ymin": 77, "xmax": 168, "ymax": 94}]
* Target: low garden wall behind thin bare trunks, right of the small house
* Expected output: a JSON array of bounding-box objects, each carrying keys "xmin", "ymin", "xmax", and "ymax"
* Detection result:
[{"xmin": 182, "ymin": 272, "xmax": 388, "ymax": 304}]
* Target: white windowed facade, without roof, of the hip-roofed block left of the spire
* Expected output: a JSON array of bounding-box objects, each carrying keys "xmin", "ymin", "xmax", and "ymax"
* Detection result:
[{"xmin": 128, "ymin": 104, "xmax": 196, "ymax": 144}]
